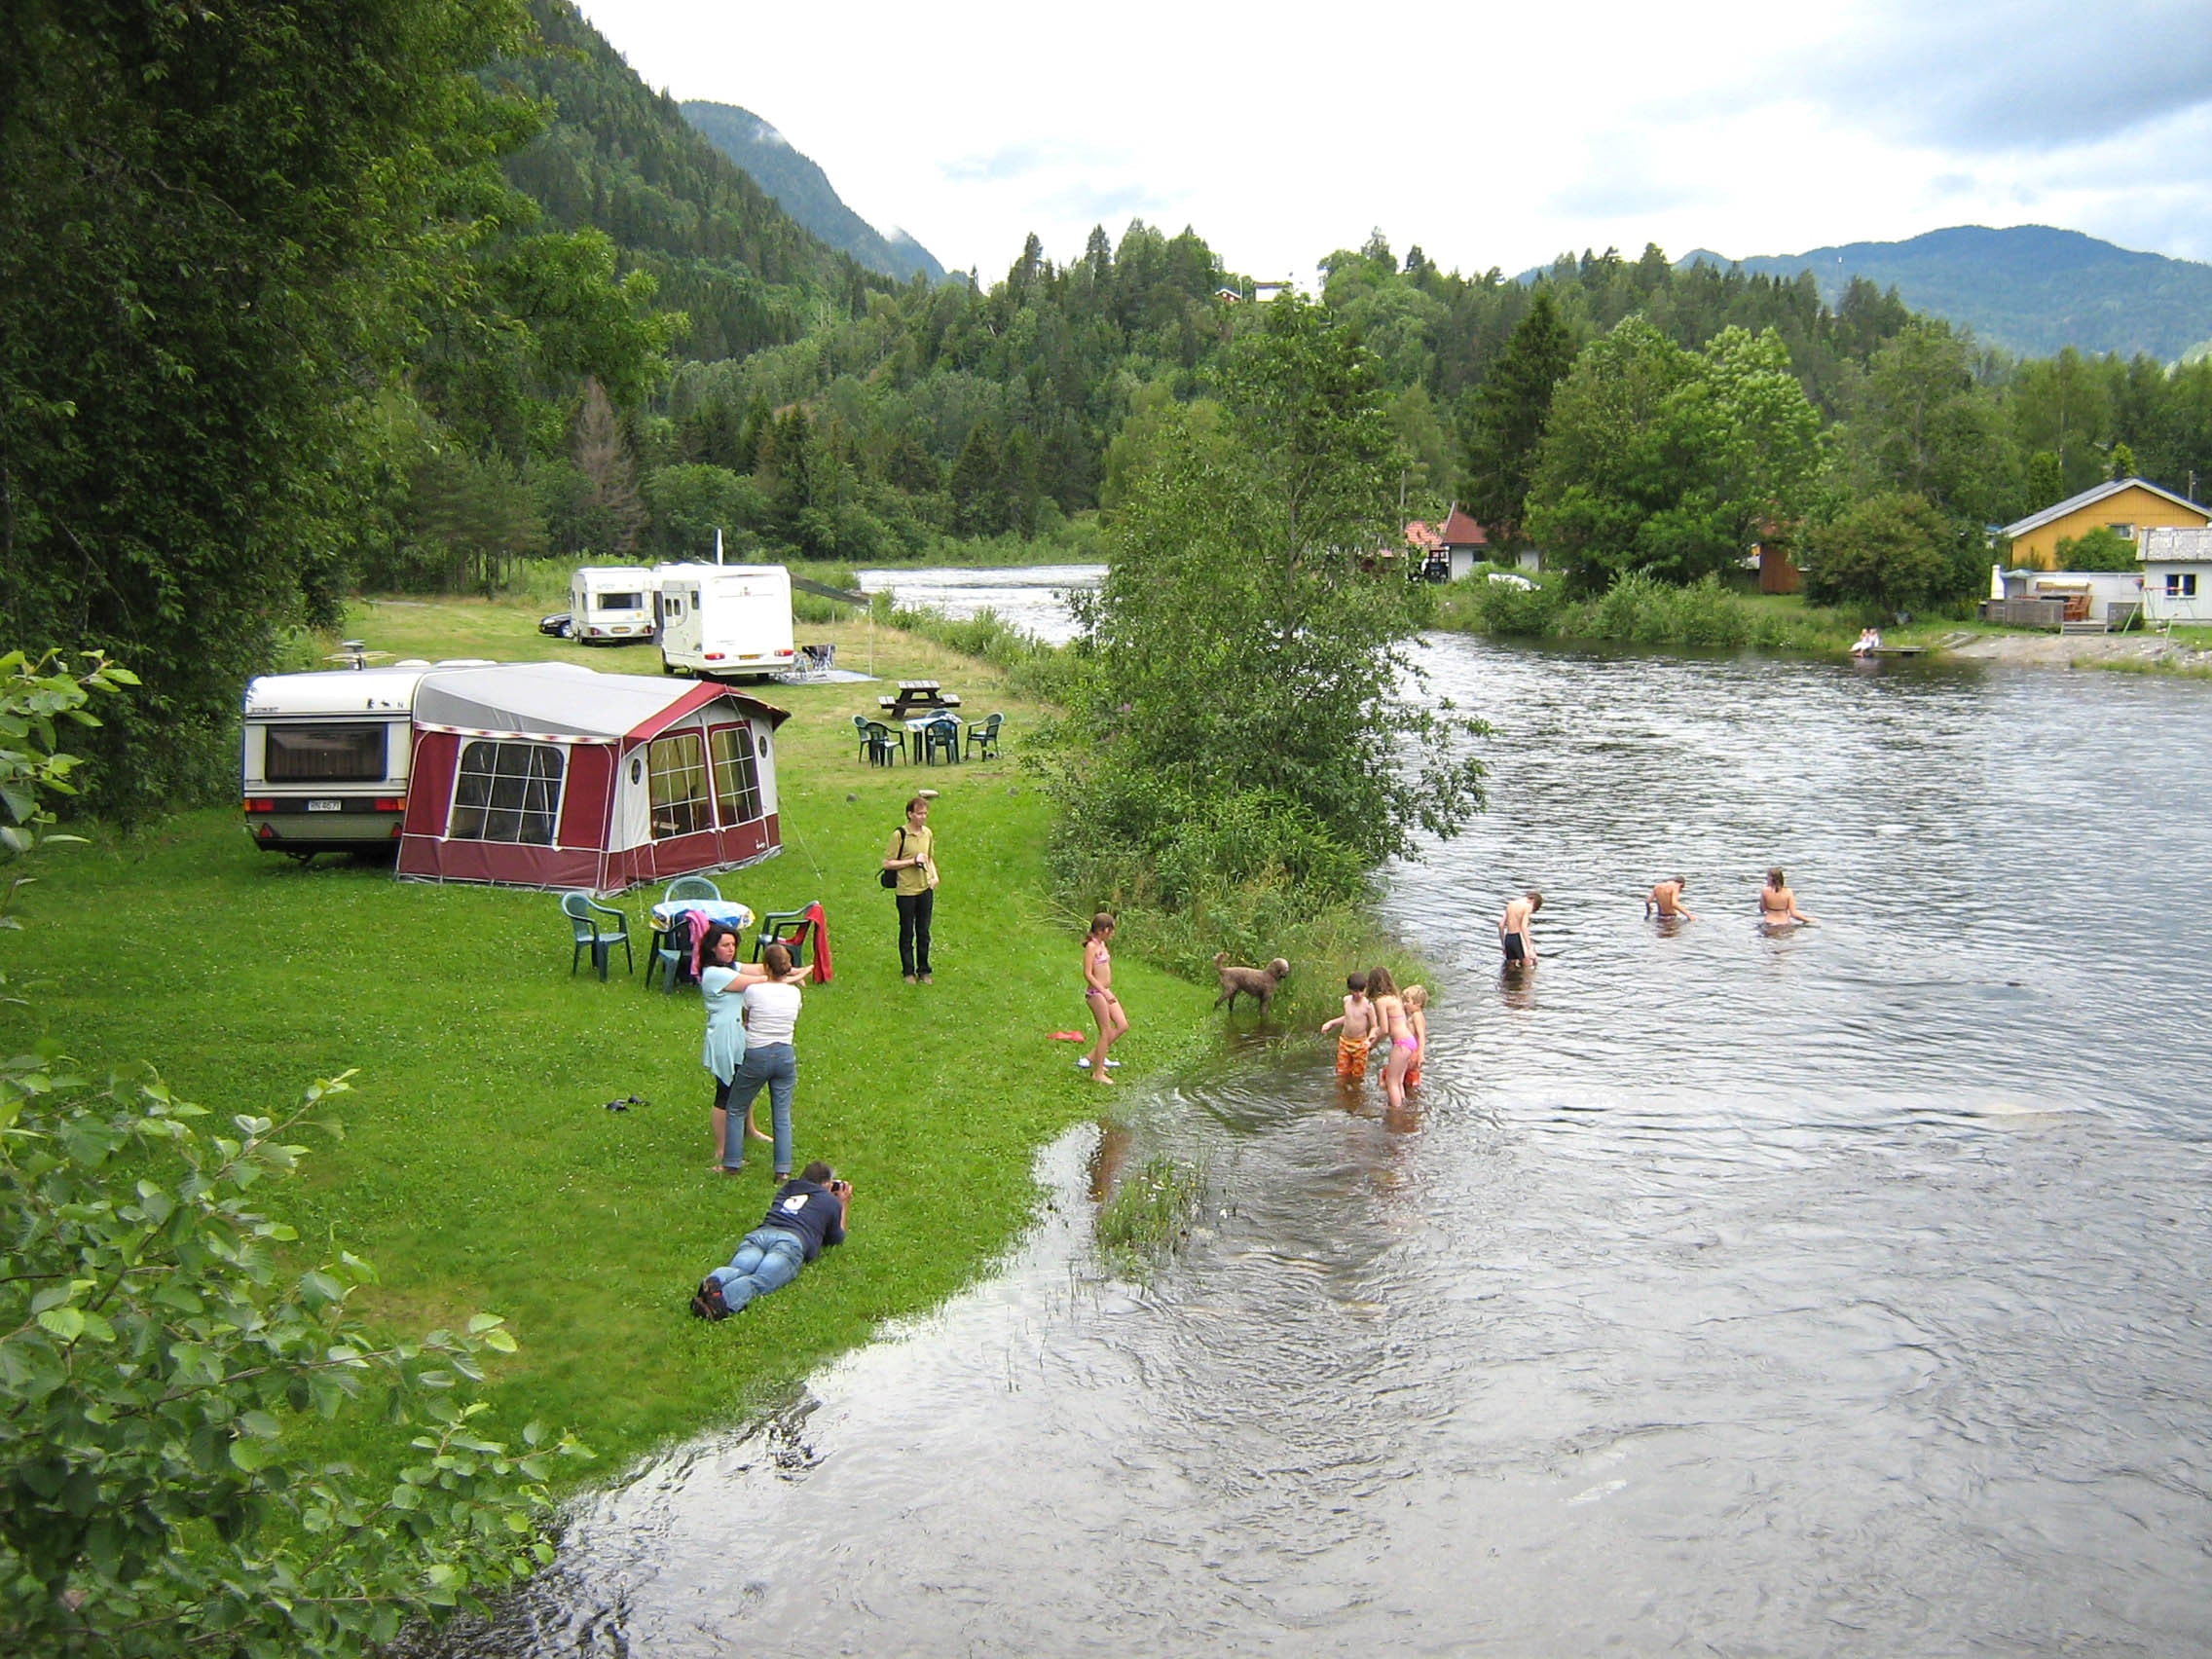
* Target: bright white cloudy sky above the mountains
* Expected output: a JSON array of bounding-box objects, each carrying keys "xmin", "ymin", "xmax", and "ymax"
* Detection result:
[{"xmin": 582, "ymin": 0, "xmax": 2212, "ymax": 283}]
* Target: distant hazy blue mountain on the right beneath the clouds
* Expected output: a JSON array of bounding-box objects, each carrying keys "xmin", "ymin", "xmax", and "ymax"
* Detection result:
[{"xmin": 1677, "ymin": 226, "xmax": 2212, "ymax": 363}]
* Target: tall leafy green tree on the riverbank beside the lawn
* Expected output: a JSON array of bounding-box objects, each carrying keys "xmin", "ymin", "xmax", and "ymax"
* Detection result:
[{"xmin": 1062, "ymin": 296, "xmax": 1480, "ymax": 903}]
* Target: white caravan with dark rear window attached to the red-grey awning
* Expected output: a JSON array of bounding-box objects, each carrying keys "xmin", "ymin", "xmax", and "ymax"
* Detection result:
[{"xmin": 239, "ymin": 659, "xmax": 495, "ymax": 863}]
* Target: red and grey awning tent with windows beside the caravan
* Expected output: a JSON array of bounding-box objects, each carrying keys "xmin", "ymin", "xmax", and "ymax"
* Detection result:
[{"xmin": 398, "ymin": 664, "xmax": 788, "ymax": 894}]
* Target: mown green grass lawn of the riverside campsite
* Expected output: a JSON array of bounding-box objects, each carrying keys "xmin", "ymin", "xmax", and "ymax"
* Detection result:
[{"xmin": 0, "ymin": 600, "xmax": 1219, "ymax": 1475}]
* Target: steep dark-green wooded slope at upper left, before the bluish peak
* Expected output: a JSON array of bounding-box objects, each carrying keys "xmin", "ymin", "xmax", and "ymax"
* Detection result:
[{"xmin": 485, "ymin": 0, "xmax": 889, "ymax": 360}]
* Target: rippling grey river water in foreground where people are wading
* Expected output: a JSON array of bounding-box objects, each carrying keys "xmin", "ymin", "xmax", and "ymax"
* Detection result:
[{"xmin": 435, "ymin": 637, "xmax": 2212, "ymax": 1657}]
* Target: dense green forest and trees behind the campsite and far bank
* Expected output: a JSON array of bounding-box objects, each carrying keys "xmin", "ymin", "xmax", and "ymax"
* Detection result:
[{"xmin": 0, "ymin": 0, "xmax": 2212, "ymax": 812}]
